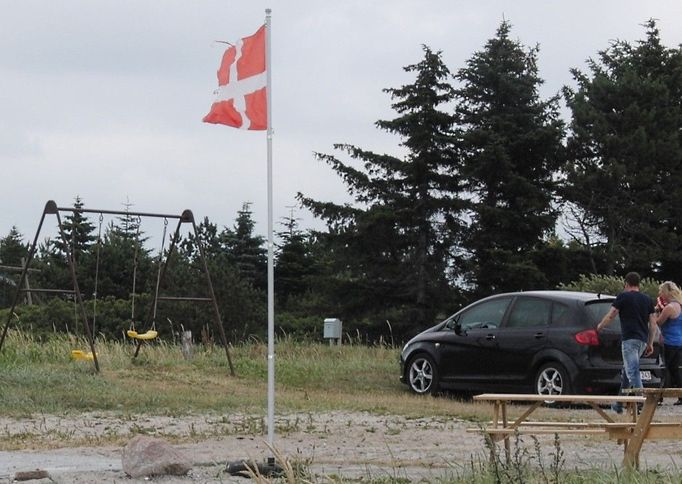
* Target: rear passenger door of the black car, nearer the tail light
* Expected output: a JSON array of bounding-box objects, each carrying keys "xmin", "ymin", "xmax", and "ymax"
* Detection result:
[{"xmin": 489, "ymin": 296, "xmax": 552, "ymax": 386}]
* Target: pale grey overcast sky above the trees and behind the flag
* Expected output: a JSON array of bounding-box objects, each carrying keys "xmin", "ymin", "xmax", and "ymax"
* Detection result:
[{"xmin": 0, "ymin": 0, "xmax": 682, "ymax": 246}]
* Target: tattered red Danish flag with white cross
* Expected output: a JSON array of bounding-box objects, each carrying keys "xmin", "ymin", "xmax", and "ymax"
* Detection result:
[{"xmin": 203, "ymin": 25, "xmax": 268, "ymax": 130}]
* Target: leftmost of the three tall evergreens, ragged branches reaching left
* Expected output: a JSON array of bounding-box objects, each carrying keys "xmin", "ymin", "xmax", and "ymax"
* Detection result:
[{"xmin": 298, "ymin": 46, "xmax": 463, "ymax": 326}]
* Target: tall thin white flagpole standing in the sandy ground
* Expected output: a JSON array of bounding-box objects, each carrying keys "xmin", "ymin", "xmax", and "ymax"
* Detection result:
[{"xmin": 265, "ymin": 8, "xmax": 275, "ymax": 448}]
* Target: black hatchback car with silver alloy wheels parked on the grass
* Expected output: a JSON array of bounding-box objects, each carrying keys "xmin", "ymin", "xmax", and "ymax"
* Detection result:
[{"xmin": 400, "ymin": 291, "xmax": 663, "ymax": 395}]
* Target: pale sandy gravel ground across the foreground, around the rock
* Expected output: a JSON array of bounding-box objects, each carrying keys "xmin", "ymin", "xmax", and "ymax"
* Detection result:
[{"xmin": 0, "ymin": 404, "xmax": 682, "ymax": 483}]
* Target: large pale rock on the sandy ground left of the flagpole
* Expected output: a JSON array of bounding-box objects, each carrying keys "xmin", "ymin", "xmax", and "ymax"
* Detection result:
[{"xmin": 121, "ymin": 435, "xmax": 192, "ymax": 477}]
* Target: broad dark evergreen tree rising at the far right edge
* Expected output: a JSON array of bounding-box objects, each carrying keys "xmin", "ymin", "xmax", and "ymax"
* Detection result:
[{"xmin": 564, "ymin": 20, "xmax": 682, "ymax": 280}]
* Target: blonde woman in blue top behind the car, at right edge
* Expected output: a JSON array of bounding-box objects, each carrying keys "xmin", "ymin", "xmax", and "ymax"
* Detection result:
[{"xmin": 656, "ymin": 281, "xmax": 682, "ymax": 405}]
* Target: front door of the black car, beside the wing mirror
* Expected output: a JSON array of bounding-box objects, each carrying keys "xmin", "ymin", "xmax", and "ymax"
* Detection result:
[{"xmin": 440, "ymin": 296, "xmax": 512, "ymax": 382}]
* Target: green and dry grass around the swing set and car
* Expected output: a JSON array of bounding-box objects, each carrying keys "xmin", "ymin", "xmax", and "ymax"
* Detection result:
[{"xmin": 0, "ymin": 331, "xmax": 682, "ymax": 484}]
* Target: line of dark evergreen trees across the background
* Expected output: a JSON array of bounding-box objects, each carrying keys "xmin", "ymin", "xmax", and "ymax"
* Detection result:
[{"xmin": 0, "ymin": 20, "xmax": 682, "ymax": 340}]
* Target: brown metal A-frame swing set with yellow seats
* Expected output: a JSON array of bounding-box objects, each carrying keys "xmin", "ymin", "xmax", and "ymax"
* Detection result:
[{"xmin": 0, "ymin": 200, "xmax": 235, "ymax": 376}]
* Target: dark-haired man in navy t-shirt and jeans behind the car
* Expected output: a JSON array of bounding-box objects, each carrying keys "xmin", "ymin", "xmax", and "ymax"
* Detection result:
[{"xmin": 596, "ymin": 272, "xmax": 656, "ymax": 413}]
